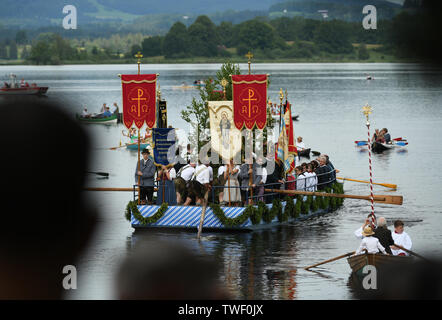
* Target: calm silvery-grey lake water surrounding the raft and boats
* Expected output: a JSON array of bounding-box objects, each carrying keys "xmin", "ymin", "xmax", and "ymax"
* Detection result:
[{"xmin": 0, "ymin": 64, "xmax": 442, "ymax": 299}]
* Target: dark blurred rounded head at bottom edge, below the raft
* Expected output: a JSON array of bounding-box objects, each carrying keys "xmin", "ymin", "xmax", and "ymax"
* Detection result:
[{"xmin": 116, "ymin": 240, "xmax": 229, "ymax": 300}]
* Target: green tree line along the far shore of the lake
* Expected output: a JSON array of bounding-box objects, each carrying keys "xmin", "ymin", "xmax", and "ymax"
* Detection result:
[{"xmin": 0, "ymin": 7, "xmax": 438, "ymax": 64}]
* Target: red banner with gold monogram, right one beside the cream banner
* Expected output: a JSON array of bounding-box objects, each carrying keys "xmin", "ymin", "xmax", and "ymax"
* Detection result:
[{"xmin": 232, "ymin": 74, "xmax": 267, "ymax": 130}]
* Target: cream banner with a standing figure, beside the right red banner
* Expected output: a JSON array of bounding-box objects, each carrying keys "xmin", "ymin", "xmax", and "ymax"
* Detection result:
[{"xmin": 208, "ymin": 101, "xmax": 241, "ymax": 160}]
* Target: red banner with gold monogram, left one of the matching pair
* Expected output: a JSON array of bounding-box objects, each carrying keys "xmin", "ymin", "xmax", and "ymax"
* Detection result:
[{"xmin": 121, "ymin": 74, "xmax": 157, "ymax": 129}]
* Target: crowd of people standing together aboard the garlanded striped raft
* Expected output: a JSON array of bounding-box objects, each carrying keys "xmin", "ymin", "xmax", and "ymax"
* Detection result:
[{"xmin": 135, "ymin": 145, "xmax": 337, "ymax": 206}]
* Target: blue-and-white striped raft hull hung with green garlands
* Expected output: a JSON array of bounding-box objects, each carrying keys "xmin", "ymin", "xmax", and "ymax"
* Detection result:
[{"xmin": 125, "ymin": 182, "xmax": 344, "ymax": 231}]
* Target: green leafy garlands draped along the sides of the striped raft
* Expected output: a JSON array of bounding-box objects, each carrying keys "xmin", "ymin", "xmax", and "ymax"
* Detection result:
[{"xmin": 125, "ymin": 183, "xmax": 344, "ymax": 227}]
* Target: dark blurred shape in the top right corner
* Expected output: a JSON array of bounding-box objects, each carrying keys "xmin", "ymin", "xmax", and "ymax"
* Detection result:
[{"xmin": 390, "ymin": 0, "xmax": 442, "ymax": 64}]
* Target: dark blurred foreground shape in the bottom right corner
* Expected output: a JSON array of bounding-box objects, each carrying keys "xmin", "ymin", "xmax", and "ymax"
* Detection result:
[{"xmin": 349, "ymin": 258, "xmax": 442, "ymax": 300}]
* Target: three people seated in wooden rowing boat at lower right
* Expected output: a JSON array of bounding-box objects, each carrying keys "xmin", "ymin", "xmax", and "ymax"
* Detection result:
[{"xmin": 354, "ymin": 215, "xmax": 412, "ymax": 256}]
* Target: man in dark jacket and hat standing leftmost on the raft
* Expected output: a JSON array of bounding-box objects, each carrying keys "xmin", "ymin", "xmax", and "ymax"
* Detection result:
[{"xmin": 135, "ymin": 149, "xmax": 156, "ymax": 204}]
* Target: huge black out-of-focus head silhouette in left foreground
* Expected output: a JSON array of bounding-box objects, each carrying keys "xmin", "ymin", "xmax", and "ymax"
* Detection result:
[{"xmin": 0, "ymin": 97, "xmax": 96, "ymax": 299}]
